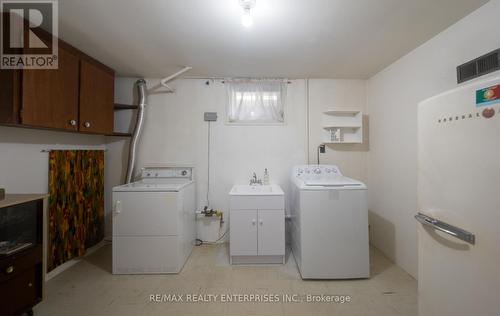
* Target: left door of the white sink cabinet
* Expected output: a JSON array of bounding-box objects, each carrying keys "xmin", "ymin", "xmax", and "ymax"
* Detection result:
[{"xmin": 229, "ymin": 210, "xmax": 257, "ymax": 256}]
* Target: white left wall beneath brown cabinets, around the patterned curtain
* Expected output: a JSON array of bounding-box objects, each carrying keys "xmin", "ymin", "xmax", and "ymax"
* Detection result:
[{"xmin": 0, "ymin": 126, "xmax": 130, "ymax": 238}]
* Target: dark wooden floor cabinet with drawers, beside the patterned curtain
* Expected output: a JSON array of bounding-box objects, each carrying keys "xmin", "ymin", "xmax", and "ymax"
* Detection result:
[{"xmin": 0, "ymin": 194, "xmax": 48, "ymax": 316}]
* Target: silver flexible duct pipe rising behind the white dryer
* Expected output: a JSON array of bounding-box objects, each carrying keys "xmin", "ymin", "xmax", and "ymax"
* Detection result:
[{"xmin": 125, "ymin": 79, "xmax": 147, "ymax": 183}]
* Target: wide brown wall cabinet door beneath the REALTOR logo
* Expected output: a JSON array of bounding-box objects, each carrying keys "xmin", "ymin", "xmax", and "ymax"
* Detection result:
[{"xmin": 21, "ymin": 47, "xmax": 78, "ymax": 130}]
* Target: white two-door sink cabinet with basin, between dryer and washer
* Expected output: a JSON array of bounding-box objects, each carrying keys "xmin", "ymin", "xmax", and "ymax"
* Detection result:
[{"xmin": 229, "ymin": 185, "xmax": 285, "ymax": 264}]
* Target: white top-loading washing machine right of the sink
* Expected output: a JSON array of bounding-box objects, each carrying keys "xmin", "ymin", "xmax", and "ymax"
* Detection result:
[{"xmin": 290, "ymin": 165, "xmax": 370, "ymax": 279}]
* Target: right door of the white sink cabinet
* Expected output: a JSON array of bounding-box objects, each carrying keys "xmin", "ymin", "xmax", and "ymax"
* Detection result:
[{"xmin": 258, "ymin": 210, "xmax": 285, "ymax": 256}]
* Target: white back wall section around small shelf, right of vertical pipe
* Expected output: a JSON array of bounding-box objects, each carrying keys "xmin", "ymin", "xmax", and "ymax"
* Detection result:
[{"xmin": 309, "ymin": 79, "xmax": 369, "ymax": 182}]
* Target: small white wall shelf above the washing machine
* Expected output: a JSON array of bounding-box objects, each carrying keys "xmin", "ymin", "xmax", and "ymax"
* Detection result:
[{"xmin": 322, "ymin": 110, "xmax": 363, "ymax": 144}]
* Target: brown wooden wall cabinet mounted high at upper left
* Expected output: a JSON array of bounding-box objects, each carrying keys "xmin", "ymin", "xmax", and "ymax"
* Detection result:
[{"xmin": 0, "ymin": 35, "xmax": 114, "ymax": 134}]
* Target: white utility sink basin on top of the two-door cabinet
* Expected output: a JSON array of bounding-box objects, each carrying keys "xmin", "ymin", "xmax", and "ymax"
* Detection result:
[{"xmin": 229, "ymin": 184, "xmax": 285, "ymax": 210}]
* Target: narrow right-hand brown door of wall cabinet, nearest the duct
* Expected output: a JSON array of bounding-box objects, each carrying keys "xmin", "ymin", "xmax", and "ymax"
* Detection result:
[{"xmin": 79, "ymin": 60, "xmax": 115, "ymax": 134}]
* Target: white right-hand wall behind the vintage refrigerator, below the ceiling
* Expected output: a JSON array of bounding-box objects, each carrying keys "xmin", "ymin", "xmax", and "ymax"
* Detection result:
[{"xmin": 367, "ymin": 0, "xmax": 500, "ymax": 276}]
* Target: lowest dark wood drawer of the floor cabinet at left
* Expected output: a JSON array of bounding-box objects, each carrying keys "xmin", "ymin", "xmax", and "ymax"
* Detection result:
[{"xmin": 0, "ymin": 267, "xmax": 41, "ymax": 316}]
